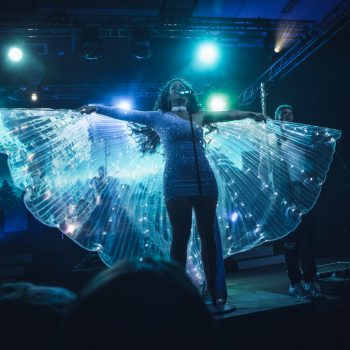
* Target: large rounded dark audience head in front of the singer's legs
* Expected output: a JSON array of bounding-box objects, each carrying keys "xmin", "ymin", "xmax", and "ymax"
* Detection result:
[{"xmin": 58, "ymin": 258, "xmax": 227, "ymax": 350}]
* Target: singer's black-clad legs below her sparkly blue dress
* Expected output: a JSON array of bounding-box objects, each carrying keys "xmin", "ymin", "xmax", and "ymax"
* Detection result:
[{"xmin": 166, "ymin": 196, "xmax": 218, "ymax": 297}]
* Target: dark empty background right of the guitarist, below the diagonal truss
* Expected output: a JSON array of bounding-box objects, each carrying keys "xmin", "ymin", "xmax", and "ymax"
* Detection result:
[{"xmin": 268, "ymin": 26, "xmax": 350, "ymax": 257}]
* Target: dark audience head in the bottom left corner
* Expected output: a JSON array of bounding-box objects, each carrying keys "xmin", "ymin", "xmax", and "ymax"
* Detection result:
[{"xmin": 0, "ymin": 282, "xmax": 75, "ymax": 350}]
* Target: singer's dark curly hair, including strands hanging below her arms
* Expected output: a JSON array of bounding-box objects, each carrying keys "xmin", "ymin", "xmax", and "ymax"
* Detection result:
[{"xmin": 129, "ymin": 78, "xmax": 218, "ymax": 154}]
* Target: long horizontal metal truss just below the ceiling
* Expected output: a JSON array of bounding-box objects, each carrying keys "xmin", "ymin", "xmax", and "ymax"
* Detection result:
[{"xmin": 0, "ymin": 15, "xmax": 314, "ymax": 46}]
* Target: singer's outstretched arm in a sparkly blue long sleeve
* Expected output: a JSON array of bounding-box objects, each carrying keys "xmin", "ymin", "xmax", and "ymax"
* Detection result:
[{"xmin": 78, "ymin": 105, "xmax": 160, "ymax": 127}]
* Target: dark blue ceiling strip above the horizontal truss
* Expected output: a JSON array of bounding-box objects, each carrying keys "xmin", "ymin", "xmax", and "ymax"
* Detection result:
[{"xmin": 0, "ymin": 0, "xmax": 339, "ymax": 21}]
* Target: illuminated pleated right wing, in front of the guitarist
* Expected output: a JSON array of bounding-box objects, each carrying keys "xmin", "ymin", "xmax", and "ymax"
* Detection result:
[{"xmin": 206, "ymin": 120, "xmax": 341, "ymax": 256}]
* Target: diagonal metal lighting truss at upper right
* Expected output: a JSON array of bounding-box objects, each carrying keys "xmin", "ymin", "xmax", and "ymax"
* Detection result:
[{"xmin": 237, "ymin": 0, "xmax": 350, "ymax": 106}]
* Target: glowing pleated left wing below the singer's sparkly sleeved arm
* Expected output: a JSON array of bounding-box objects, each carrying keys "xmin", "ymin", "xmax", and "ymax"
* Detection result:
[{"xmin": 0, "ymin": 109, "xmax": 171, "ymax": 265}]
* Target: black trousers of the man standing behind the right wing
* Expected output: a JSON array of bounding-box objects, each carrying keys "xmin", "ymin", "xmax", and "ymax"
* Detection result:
[{"xmin": 284, "ymin": 211, "xmax": 316, "ymax": 284}]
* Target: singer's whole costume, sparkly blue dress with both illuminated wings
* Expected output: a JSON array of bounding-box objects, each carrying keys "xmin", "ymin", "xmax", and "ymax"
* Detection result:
[{"xmin": 0, "ymin": 107, "xmax": 341, "ymax": 282}]
